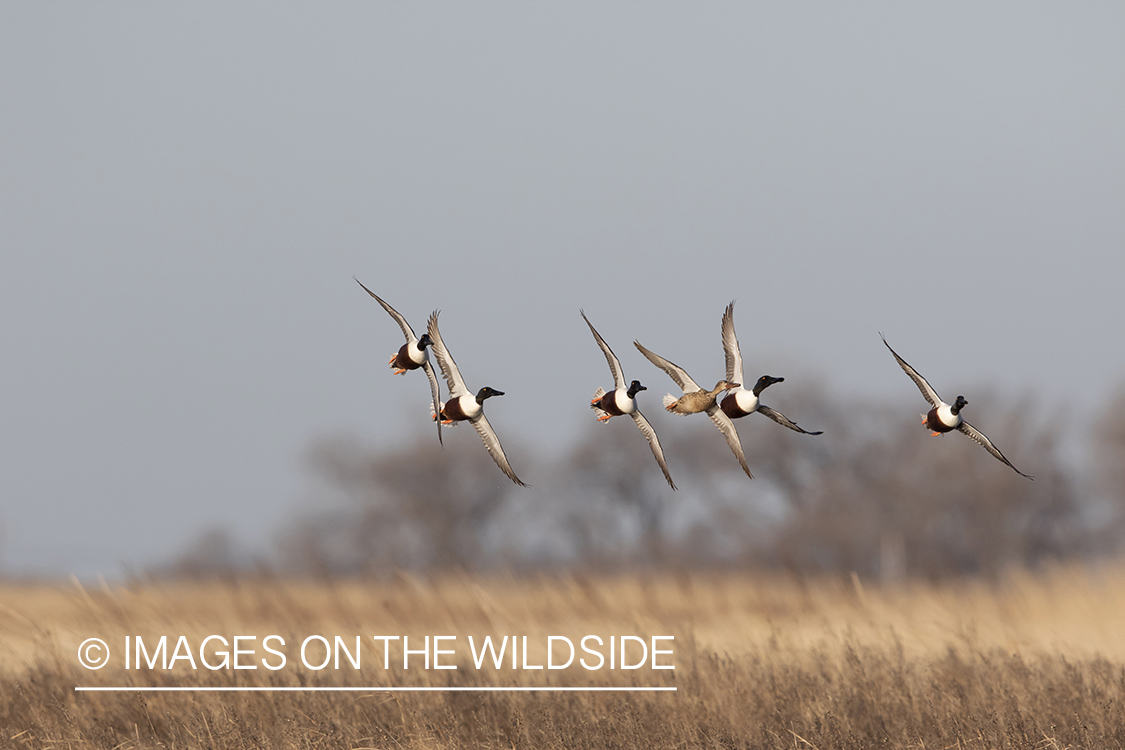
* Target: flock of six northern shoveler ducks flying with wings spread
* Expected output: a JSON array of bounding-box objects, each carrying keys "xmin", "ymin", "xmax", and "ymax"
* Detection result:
[{"xmin": 352, "ymin": 277, "xmax": 1032, "ymax": 489}]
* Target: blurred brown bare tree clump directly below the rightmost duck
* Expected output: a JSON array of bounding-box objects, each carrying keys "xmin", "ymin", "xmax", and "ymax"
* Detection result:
[{"xmin": 776, "ymin": 398, "xmax": 1081, "ymax": 577}]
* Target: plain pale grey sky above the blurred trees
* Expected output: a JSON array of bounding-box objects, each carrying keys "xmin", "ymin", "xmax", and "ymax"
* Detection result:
[{"xmin": 0, "ymin": 2, "xmax": 1125, "ymax": 576}]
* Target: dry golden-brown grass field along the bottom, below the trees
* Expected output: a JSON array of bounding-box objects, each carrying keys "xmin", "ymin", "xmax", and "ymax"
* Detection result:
[{"xmin": 0, "ymin": 568, "xmax": 1125, "ymax": 750}]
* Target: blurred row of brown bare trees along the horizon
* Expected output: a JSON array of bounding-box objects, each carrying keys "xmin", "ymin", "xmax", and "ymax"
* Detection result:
[{"xmin": 165, "ymin": 382, "xmax": 1125, "ymax": 580}]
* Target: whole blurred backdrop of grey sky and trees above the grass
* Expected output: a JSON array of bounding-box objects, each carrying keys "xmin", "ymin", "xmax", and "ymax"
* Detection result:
[{"xmin": 0, "ymin": 2, "xmax": 1125, "ymax": 580}]
